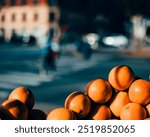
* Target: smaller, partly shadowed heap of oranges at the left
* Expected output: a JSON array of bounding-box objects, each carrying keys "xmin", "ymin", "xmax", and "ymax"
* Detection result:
[{"xmin": 0, "ymin": 87, "xmax": 46, "ymax": 120}]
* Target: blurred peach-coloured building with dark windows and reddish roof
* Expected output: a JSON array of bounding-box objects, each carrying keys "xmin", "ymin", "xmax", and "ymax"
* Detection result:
[{"xmin": 0, "ymin": 0, "xmax": 60, "ymax": 46}]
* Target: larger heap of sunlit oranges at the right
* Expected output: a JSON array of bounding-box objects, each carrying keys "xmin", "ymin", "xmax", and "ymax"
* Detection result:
[{"xmin": 47, "ymin": 65, "xmax": 150, "ymax": 120}]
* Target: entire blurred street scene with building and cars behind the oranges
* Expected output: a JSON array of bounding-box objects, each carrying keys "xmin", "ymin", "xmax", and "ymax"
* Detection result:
[{"xmin": 0, "ymin": 0, "xmax": 150, "ymax": 112}]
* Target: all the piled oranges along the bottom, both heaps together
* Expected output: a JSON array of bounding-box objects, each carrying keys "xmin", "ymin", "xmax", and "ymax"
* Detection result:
[{"xmin": 0, "ymin": 65, "xmax": 150, "ymax": 120}]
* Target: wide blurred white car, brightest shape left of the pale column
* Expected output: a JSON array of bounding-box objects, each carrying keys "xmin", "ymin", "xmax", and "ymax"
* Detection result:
[{"xmin": 102, "ymin": 34, "xmax": 129, "ymax": 49}]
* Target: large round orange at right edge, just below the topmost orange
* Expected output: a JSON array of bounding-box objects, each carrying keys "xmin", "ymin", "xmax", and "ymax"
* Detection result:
[{"xmin": 129, "ymin": 79, "xmax": 150, "ymax": 105}]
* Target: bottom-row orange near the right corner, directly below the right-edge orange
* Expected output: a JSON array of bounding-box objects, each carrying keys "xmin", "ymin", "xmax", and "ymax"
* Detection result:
[{"xmin": 120, "ymin": 103, "xmax": 146, "ymax": 120}]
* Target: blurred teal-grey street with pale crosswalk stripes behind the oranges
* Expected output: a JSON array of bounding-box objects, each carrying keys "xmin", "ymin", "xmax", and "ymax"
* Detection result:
[{"xmin": 0, "ymin": 47, "xmax": 150, "ymax": 112}]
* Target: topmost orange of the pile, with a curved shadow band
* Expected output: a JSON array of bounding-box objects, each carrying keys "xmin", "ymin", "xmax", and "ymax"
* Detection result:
[{"xmin": 108, "ymin": 65, "xmax": 135, "ymax": 91}]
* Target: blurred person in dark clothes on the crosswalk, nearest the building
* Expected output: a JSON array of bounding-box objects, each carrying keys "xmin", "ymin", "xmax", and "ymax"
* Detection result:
[{"xmin": 41, "ymin": 25, "xmax": 61, "ymax": 75}]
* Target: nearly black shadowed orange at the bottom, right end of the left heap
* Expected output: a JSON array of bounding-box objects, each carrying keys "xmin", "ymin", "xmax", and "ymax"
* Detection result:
[{"xmin": 28, "ymin": 109, "xmax": 46, "ymax": 120}]
